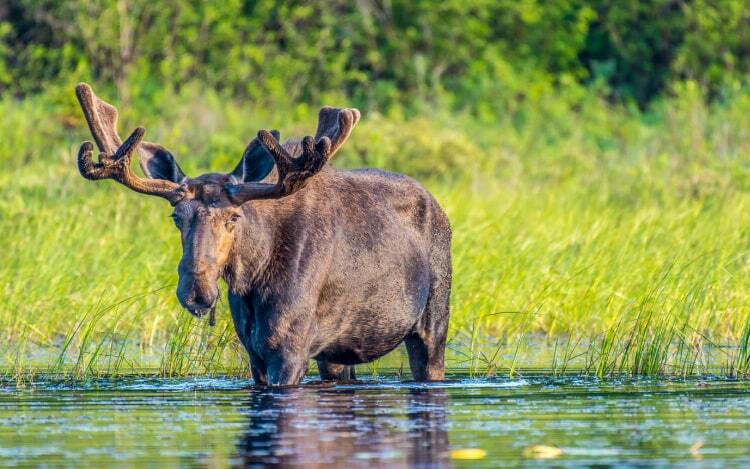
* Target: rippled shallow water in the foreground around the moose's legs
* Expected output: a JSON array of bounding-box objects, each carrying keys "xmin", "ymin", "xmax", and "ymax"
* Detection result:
[{"xmin": 0, "ymin": 377, "xmax": 750, "ymax": 467}]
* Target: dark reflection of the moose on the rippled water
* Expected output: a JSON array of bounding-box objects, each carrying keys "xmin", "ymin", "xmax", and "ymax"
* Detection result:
[{"xmin": 237, "ymin": 387, "xmax": 449, "ymax": 467}]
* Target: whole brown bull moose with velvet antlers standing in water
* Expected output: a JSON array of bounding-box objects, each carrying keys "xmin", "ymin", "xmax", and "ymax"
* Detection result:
[{"xmin": 76, "ymin": 83, "xmax": 451, "ymax": 385}]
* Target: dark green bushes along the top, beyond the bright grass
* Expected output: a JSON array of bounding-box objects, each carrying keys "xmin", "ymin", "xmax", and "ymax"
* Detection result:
[{"xmin": 5, "ymin": 0, "xmax": 750, "ymax": 107}]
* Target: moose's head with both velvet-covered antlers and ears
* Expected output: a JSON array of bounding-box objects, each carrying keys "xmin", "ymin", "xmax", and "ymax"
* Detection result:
[{"xmin": 76, "ymin": 83, "xmax": 360, "ymax": 317}]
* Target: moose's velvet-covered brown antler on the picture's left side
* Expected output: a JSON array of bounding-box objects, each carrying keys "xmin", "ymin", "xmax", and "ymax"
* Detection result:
[{"xmin": 76, "ymin": 83, "xmax": 184, "ymax": 205}]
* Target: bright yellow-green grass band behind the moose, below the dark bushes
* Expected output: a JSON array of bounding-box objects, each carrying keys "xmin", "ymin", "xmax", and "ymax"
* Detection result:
[{"xmin": 0, "ymin": 81, "xmax": 750, "ymax": 381}]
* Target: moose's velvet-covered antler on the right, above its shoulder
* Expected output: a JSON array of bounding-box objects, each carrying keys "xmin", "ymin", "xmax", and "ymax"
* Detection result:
[{"xmin": 225, "ymin": 107, "xmax": 360, "ymax": 205}]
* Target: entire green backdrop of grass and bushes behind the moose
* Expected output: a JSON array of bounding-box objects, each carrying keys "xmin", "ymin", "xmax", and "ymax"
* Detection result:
[{"xmin": 0, "ymin": 0, "xmax": 750, "ymax": 381}]
